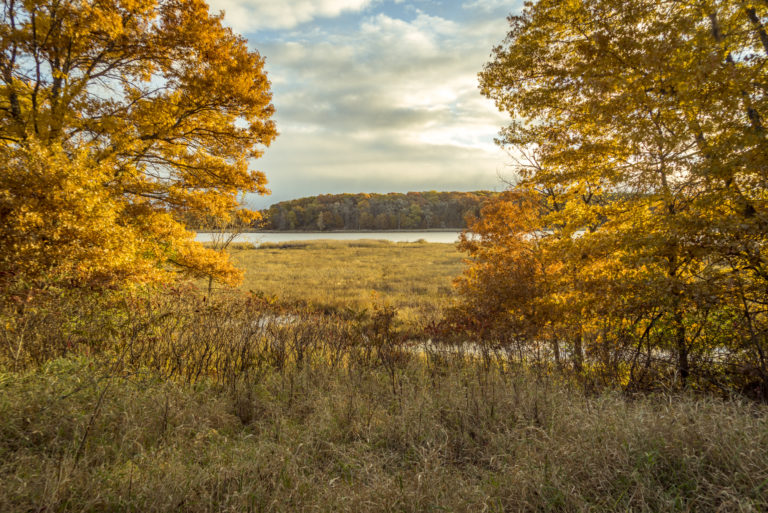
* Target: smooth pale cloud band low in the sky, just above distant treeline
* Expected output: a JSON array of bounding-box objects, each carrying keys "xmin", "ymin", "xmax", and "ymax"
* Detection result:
[{"xmin": 248, "ymin": 132, "xmax": 510, "ymax": 208}]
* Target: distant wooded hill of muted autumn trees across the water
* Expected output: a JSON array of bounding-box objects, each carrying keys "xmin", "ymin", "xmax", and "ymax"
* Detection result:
[{"xmin": 262, "ymin": 191, "xmax": 497, "ymax": 230}]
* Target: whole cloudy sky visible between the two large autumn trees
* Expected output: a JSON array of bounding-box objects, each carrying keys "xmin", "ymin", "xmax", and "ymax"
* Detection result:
[{"xmin": 204, "ymin": 0, "xmax": 522, "ymax": 208}]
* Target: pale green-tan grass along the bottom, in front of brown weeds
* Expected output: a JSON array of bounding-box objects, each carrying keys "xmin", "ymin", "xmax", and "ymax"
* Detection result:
[{"xmin": 0, "ymin": 355, "xmax": 768, "ymax": 513}]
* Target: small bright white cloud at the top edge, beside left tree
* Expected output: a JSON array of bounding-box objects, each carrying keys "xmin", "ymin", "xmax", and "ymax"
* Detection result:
[{"xmin": 209, "ymin": 0, "xmax": 371, "ymax": 31}]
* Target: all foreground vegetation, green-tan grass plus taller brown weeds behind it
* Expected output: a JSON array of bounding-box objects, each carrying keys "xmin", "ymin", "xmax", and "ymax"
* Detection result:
[{"xmin": 0, "ymin": 290, "xmax": 768, "ymax": 512}]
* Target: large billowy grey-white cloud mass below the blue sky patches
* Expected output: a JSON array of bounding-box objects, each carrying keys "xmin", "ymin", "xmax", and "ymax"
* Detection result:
[{"xmin": 264, "ymin": 13, "xmax": 505, "ymax": 149}]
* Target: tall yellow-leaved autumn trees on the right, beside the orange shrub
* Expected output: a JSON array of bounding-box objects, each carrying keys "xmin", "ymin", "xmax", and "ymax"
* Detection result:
[{"xmin": 462, "ymin": 0, "xmax": 768, "ymax": 394}]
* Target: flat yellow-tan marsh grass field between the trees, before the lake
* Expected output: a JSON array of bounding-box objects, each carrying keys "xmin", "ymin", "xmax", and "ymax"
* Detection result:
[{"xmin": 219, "ymin": 240, "xmax": 462, "ymax": 319}]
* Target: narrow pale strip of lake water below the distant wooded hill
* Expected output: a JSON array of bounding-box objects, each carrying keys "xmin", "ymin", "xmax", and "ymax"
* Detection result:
[{"xmin": 196, "ymin": 230, "xmax": 461, "ymax": 245}]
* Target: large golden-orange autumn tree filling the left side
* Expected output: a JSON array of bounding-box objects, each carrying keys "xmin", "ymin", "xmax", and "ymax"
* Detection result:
[{"xmin": 0, "ymin": 0, "xmax": 276, "ymax": 285}]
